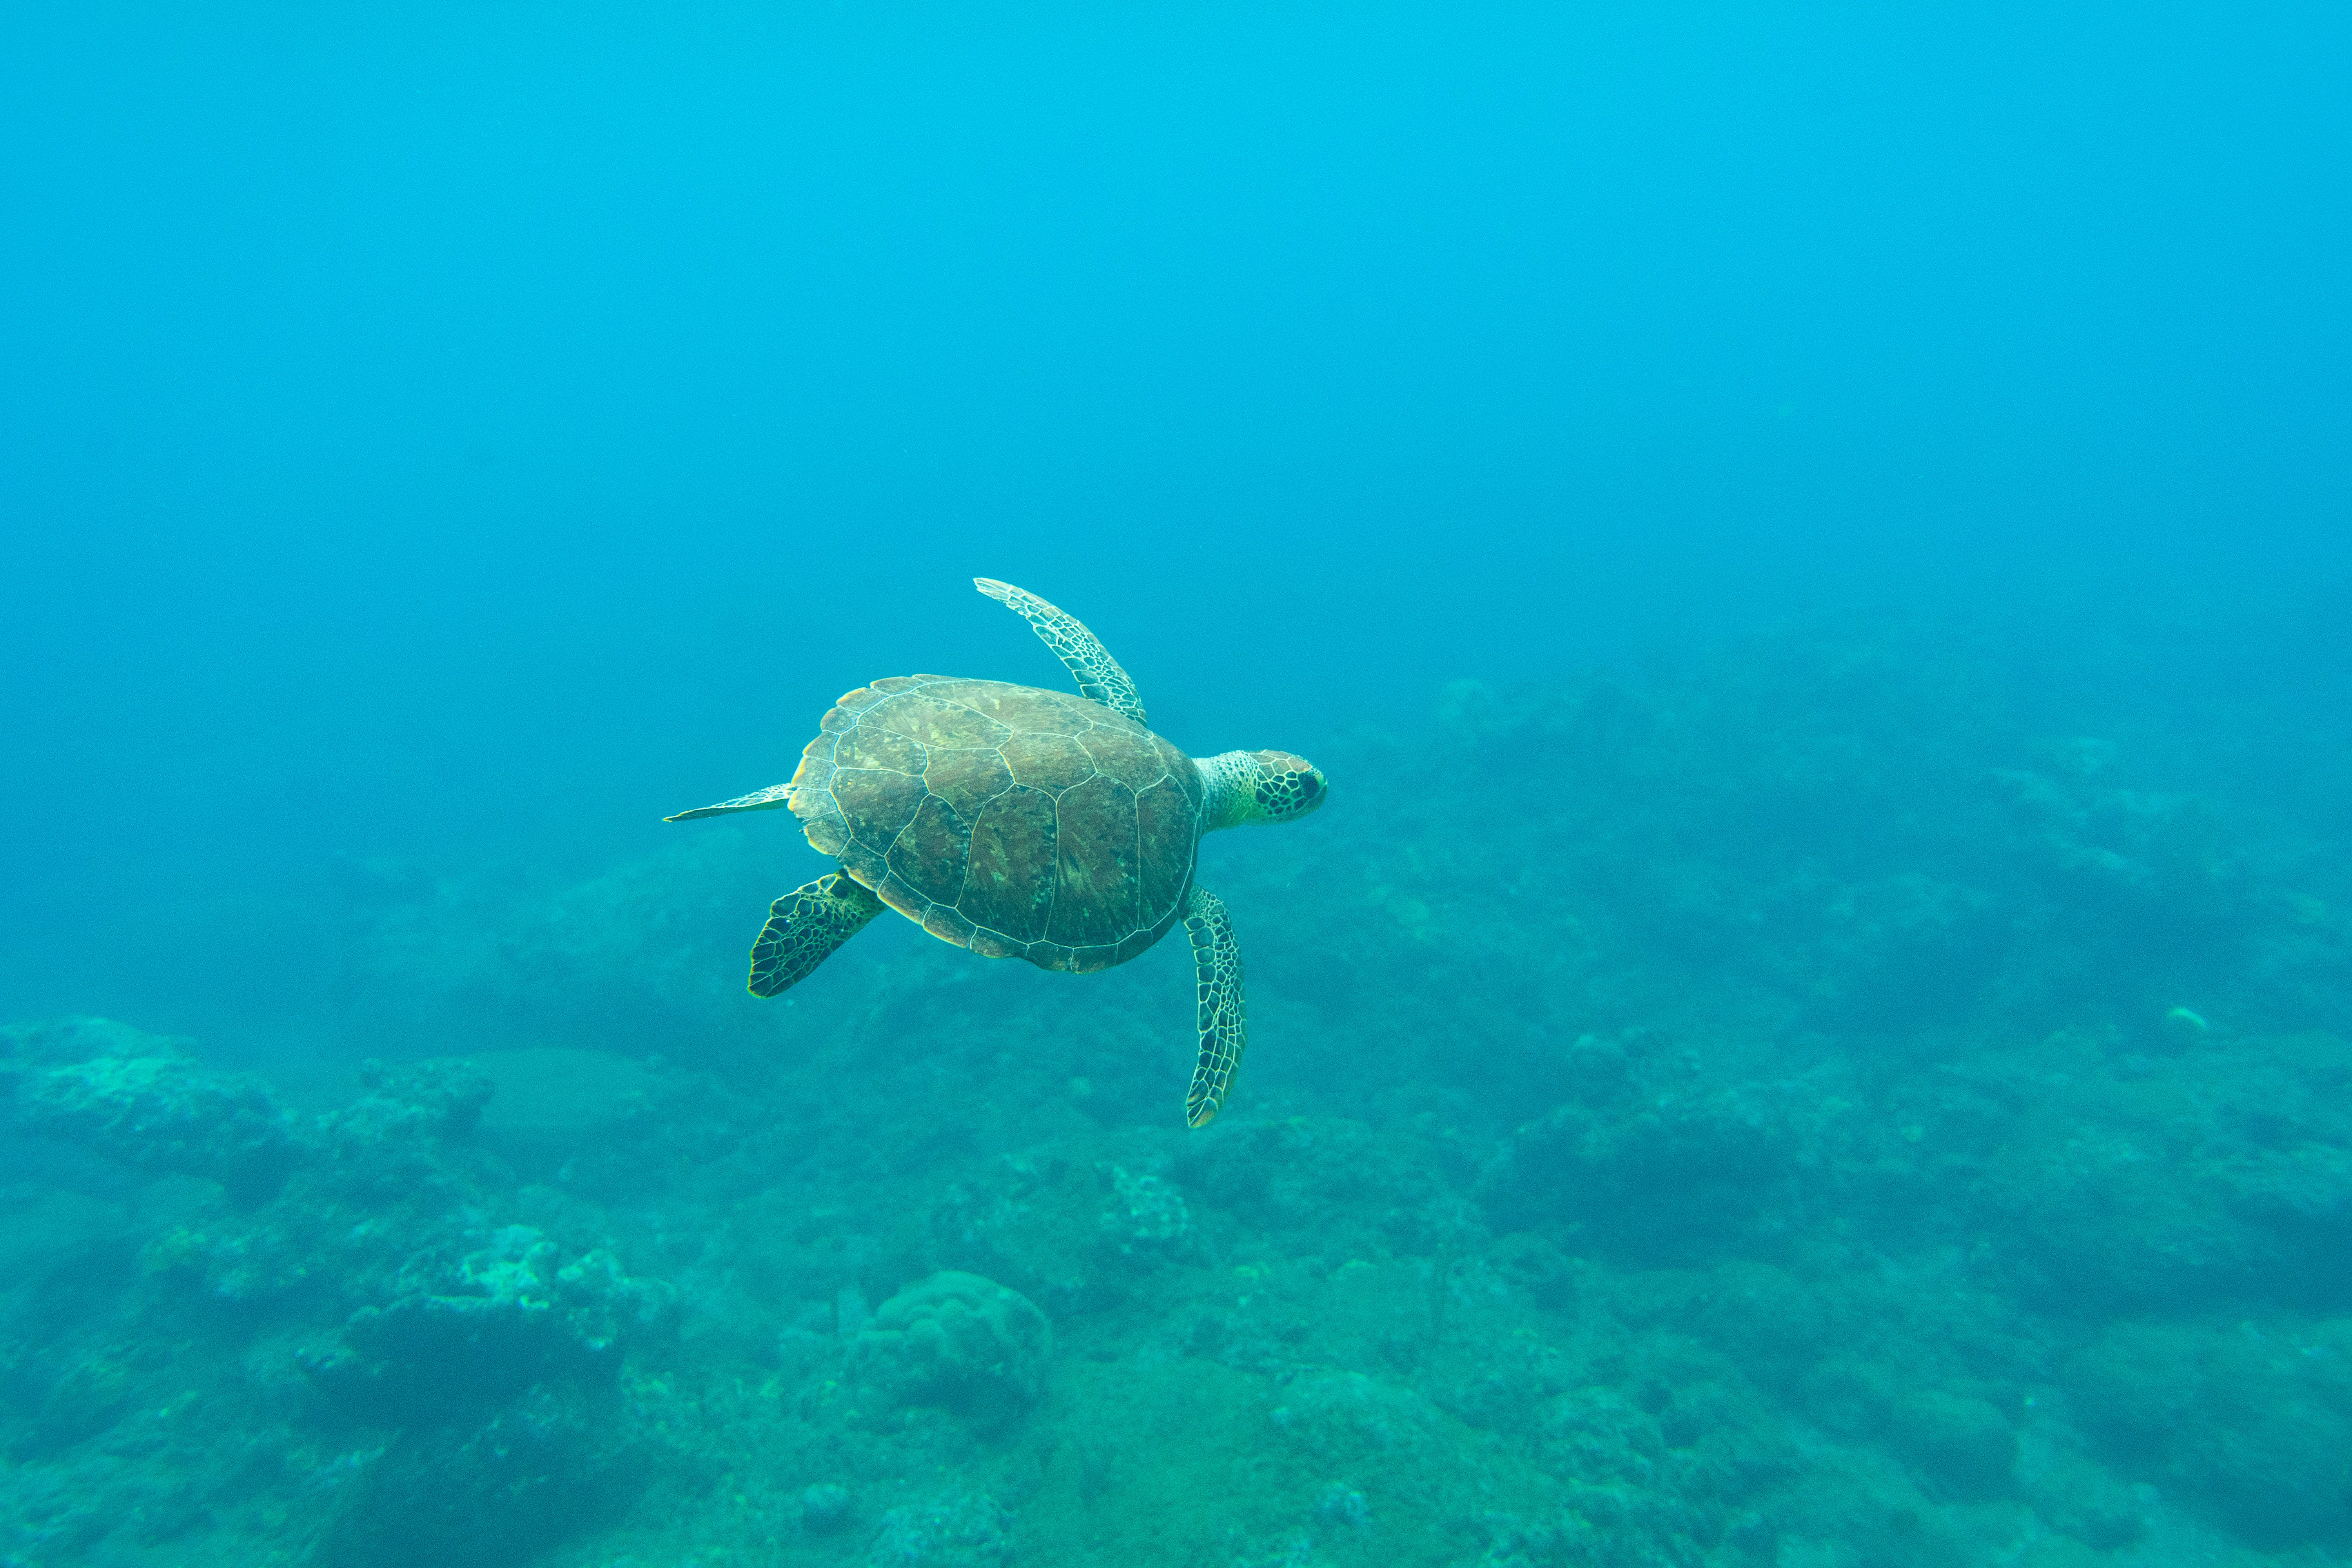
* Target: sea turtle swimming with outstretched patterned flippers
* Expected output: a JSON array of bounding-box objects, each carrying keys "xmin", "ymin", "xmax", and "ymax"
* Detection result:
[{"xmin": 663, "ymin": 578, "xmax": 1331, "ymax": 1126}]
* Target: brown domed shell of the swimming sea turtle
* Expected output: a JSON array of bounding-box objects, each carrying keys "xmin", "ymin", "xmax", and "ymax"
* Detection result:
[{"xmin": 793, "ymin": 675, "xmax": 1207, "ymax": 973}]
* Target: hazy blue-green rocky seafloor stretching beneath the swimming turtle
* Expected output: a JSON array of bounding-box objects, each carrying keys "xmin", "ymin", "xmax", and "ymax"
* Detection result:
[{"xmin": 0, "ymin": 621, "xmax": 2352, "ymax": 1568}]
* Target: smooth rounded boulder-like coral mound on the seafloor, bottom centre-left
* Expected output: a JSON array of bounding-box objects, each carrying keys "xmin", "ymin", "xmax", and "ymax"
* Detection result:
[{"xmin": 856, "ymin": 1272, "xmax": 1054, "ymax": 1425}]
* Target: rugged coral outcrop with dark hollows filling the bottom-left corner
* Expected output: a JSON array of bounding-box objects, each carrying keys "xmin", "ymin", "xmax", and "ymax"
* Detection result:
[{"xmin": 0, "ymin": 1020, "xmax": 673, "ymax": 1566}]
